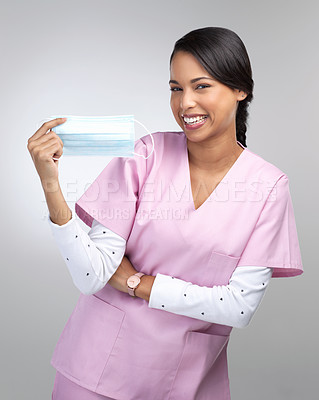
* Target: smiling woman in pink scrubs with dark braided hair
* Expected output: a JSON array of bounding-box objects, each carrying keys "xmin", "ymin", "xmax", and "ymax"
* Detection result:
[{"xmin": 28, "ymin": 27, "xmax": 303, "ymax": 400}]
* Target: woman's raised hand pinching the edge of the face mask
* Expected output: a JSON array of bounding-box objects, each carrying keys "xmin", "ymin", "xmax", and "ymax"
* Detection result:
[{"xmin": 27, "ymin": 118, "xmax": 67, "ymax": 183}]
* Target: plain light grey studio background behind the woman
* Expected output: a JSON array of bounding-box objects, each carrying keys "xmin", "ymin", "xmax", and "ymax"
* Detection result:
[{"xmin": 0, "ymin": 0, "xmax": 319, "ymax": 400}]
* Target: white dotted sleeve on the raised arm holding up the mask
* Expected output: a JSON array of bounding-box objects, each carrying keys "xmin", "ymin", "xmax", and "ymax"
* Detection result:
[{"xmin": 48, "ymin": 213, "xmax": 126, "ymax": 295}]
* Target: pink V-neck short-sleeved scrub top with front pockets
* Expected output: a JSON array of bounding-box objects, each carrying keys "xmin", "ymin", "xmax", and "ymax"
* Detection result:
[{"xmin": 51, "ymin": 131, "xmax": 303, "ymax": 400}]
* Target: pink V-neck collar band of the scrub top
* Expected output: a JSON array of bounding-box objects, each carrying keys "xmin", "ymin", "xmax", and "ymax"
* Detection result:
[{"xmin": 184, "ymin": 133, "xmax": 247, "ymax": 213}]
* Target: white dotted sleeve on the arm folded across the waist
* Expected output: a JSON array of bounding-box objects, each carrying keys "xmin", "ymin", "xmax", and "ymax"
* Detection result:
[{"xmin": 148, "ymin": 266, "xmax": 272, "ymax": 328}]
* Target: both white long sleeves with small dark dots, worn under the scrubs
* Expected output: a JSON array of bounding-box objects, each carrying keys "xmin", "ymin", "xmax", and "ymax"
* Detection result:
[{"xmin": 48, "ymin": 213, "xmax": 272, "ymax": 328}]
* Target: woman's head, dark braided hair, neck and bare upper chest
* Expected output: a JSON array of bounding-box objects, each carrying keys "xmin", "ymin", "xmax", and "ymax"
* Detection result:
[{"xmin": 169, "ymin": 28, "xmax": 254, "ymax": 212}]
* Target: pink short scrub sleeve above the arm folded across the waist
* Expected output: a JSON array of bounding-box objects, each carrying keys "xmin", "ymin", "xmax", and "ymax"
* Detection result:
[{"xmin": 238, "ymin": 175, "xmax": 303, "ymax": 278}]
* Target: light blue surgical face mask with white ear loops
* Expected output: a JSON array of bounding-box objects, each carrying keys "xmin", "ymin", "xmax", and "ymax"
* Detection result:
[{"xmin": 41, "ymin": 115, "xmax": 154, "ymax": 159}]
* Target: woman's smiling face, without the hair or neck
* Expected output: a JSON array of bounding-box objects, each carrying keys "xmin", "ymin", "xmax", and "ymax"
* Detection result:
[{"xmin": 169, "ymin": 51, "xmax": 246, "ymax": 141}]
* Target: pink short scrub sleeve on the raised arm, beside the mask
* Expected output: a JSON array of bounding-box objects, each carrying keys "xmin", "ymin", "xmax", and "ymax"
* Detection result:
[{"xmin": 75, "ymin": 138, "xmax": 152, "ymax": 240}]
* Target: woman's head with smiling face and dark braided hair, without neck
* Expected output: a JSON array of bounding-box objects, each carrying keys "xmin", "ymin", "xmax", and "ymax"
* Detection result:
[{"xmin": 169, "ymin": 28, "xmax": 254, "ymax": 146}]
